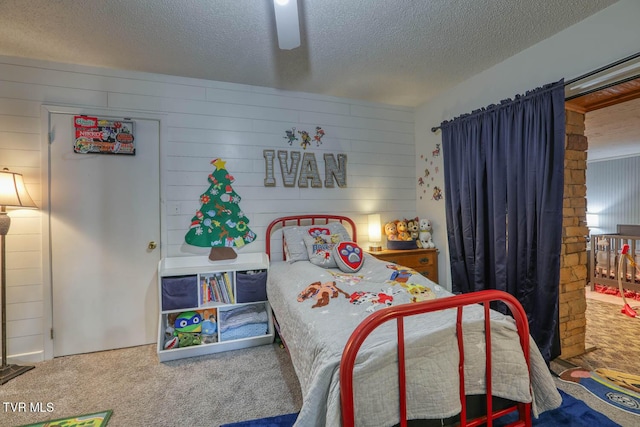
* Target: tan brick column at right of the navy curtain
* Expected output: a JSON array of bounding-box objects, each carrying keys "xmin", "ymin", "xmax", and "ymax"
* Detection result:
[{"xmin": 559, "ymin": 110, "xmax": 589, "ymax": 359}]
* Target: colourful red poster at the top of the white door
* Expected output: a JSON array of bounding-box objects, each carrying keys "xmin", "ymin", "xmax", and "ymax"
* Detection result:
[{"xmin": 73, "ymin": 116, "xmax": 136, "ymax": 155}]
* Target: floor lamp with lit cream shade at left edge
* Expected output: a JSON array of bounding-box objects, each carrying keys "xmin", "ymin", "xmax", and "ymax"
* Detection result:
[{"xmin": 0, "ymin": 168, "xmax": 37, "ymax": 384}]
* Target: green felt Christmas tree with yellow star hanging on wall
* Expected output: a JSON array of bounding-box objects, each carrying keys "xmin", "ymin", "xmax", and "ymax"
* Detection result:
[{"xmin": 185, "ymin": 159, "xmax": 256, "ymax": 261}]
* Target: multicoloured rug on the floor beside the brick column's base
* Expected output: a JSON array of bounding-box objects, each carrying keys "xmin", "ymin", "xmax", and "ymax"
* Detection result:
[{"xmin": 560, "ymin": 368, "xmax": 640, "ymax": 423}]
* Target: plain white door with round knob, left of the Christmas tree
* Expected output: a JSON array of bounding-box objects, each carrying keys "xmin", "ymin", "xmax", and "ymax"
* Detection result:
[{"xmin": 49, "ymin": 113, "xmax": 160, "ymax": 357}]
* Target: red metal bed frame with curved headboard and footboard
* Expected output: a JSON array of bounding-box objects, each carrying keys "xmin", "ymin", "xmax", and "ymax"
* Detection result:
[{"xmin": 266, "ymin": 214, "xmax": 531, "ymax": 427}]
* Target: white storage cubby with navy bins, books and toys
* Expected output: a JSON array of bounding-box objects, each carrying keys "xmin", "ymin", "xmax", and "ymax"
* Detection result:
[{"xmin": 157, "ymin": 253, "xmax": 275, "ymax": 362}]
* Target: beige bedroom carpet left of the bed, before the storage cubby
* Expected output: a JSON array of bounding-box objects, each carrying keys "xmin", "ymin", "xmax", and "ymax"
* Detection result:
[{"xmin": 0, "ymin": 344, "xmax": 302, "ymax": 427}]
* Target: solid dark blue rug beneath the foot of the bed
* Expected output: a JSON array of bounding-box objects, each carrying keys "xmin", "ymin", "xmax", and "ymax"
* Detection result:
[{"xmin": 220, "ymin": 390, "xmax": 619, "ymax": 427}]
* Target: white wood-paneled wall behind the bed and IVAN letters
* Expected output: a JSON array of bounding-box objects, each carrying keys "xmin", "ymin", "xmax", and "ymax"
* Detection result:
[{"xmin": 0, "ymin": 56, "xmax": 416, "ymax": 361}]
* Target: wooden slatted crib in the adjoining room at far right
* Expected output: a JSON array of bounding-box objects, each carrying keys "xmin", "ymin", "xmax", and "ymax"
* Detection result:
[{"xmin": 589, "ymin": 224, "xmax": 640, "ymax": 294}]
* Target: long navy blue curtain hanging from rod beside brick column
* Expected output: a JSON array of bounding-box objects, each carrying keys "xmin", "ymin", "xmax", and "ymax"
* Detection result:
[{"xmin": 441, "ymin": 80, "xmax": 565, "ymax": 363}]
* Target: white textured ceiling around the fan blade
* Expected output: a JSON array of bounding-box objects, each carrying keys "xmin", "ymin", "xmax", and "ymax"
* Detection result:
[{"xmin": 0, "ymin": 0, "xmax": 615, "ymax": 106}]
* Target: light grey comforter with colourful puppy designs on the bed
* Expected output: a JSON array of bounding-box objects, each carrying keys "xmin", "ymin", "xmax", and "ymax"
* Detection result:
[{"xmin": 267, "ymin": 254, "xmax": 561, "ymax": 427}]
